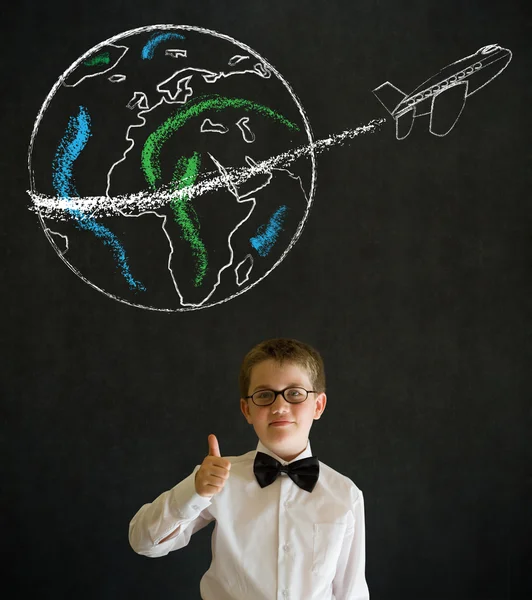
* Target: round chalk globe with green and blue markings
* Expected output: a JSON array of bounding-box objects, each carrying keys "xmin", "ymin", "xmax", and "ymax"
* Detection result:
[{"xmin": 28, "ymin": 25, "xmax": 316, "ymax": 312}]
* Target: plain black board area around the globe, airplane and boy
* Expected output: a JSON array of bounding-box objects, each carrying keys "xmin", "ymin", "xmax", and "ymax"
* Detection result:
[{"xmin": 0, "ymin": 0, "xmax": 532, "ymax": 600}]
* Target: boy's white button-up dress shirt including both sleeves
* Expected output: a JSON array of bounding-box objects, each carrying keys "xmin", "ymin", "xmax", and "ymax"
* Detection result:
[{"xmin": 129, "ymin": 440, "xmax": 369, "ymax": 600}]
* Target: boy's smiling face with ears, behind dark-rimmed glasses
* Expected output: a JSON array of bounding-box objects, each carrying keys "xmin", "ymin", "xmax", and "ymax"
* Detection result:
[{"xmin": 240, "ymin": 359, "xmax": 327, "ymax": 462}]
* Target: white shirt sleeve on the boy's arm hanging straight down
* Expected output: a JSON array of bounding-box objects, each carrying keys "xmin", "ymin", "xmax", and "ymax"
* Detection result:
[{"xmin": 333, "ymin": 489, "xmax": 369, "ymax": 600}]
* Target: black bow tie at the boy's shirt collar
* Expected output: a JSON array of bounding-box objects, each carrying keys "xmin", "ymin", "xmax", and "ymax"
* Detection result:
[{"xmin": 253, "ymin": 452, "xmax": 320, "ymax": 492}]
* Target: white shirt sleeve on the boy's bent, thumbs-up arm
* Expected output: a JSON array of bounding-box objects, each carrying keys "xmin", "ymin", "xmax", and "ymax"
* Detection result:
[{"xmin": 129, "ymin": 465, "xmax": 214, "ymax": 558}]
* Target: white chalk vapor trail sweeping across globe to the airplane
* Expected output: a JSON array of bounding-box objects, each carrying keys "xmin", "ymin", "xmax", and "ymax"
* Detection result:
[{"xmin": 28, "ymin": 118, "xmax": 386, "ymax": 220}]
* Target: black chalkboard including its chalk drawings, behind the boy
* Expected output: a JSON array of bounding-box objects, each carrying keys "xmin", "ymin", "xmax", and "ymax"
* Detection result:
[{"xmin": 0, "ymin": 0, "xmax": 532, "ymax": 600}]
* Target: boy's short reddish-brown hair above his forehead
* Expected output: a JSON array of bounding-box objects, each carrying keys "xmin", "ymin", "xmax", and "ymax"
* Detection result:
[{"xmin": 239, "ymin": 338, "xmax": 325, "ymax": 398}]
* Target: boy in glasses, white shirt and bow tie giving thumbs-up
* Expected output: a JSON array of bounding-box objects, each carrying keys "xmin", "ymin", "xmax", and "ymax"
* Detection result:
[{"xmin": 129, "ymin": 338, "xmax": 369, "ymax": 600}]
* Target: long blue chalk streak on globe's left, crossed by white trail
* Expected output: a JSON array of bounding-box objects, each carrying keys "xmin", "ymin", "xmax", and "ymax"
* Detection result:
[{"xmin": 52, "ymin": 106, "xmax": 146, "ymax": 291}]
